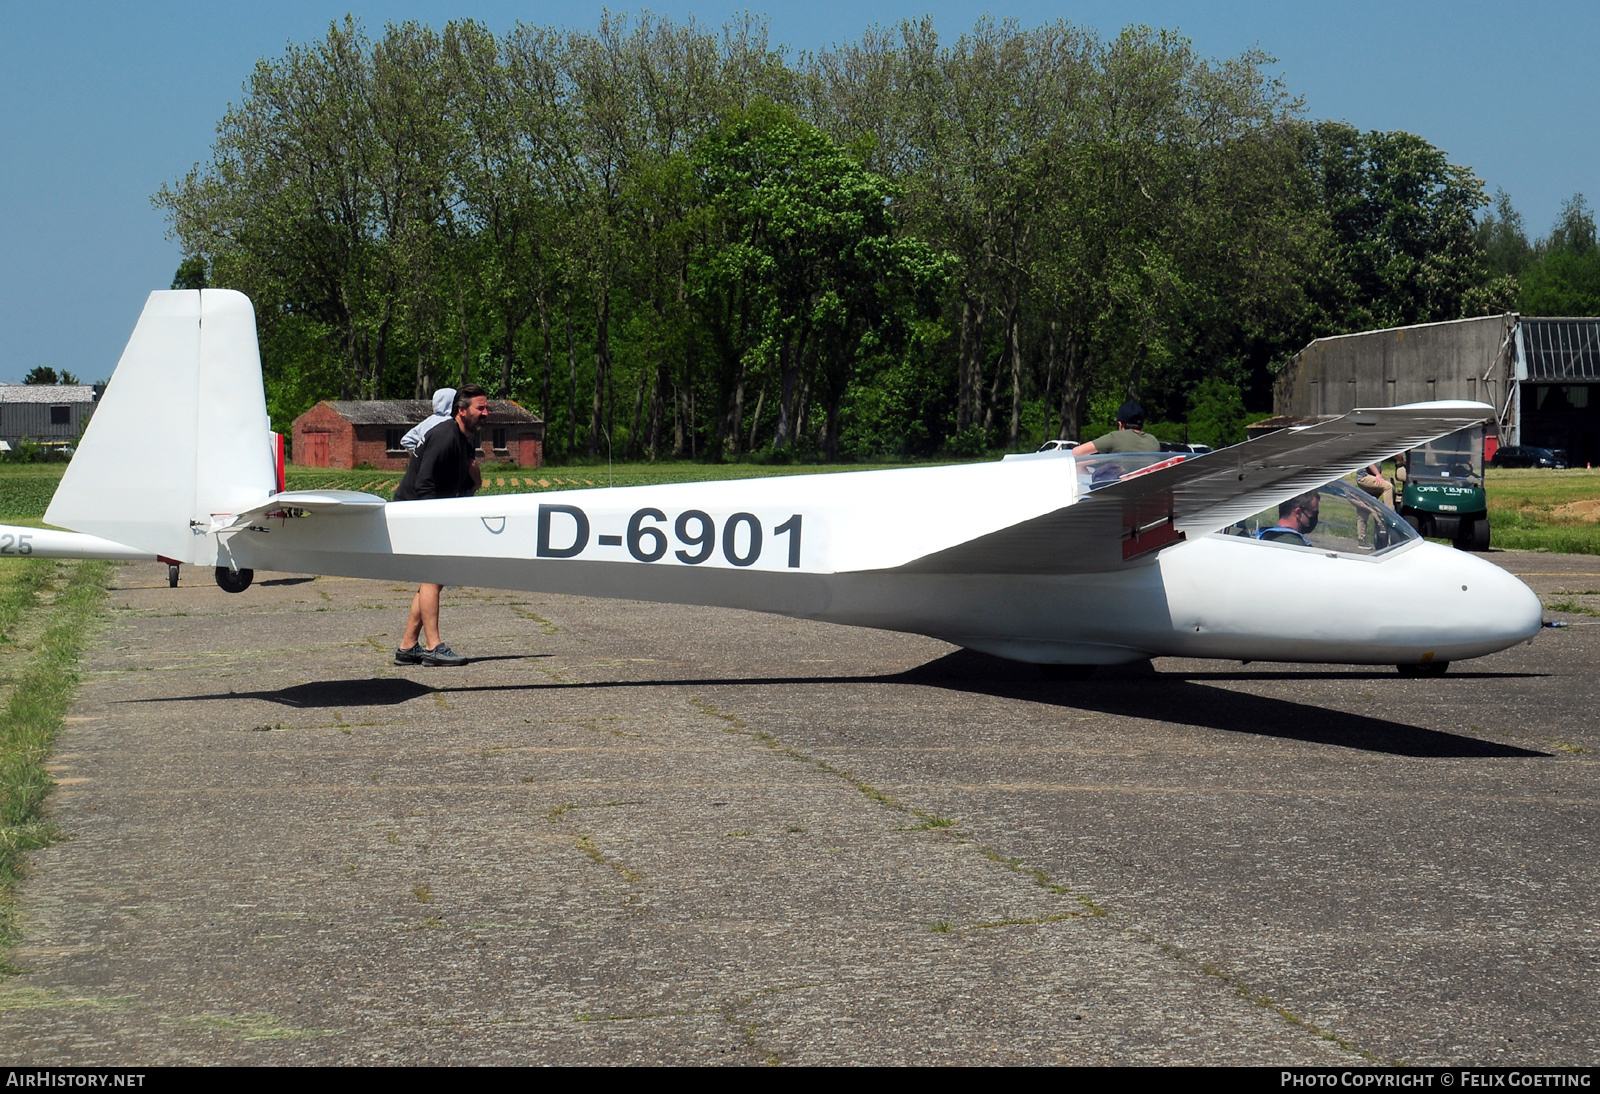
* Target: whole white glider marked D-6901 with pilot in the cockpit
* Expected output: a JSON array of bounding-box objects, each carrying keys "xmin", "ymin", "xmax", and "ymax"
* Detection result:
[{"xmin": 9, "ymin": 289, "xmax": 1542, "ymax": 672}]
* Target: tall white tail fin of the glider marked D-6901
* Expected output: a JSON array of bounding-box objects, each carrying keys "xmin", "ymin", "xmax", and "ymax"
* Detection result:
[{"xmin": 45, "ymin": 289, "xmax": 277, "ymax": 566}]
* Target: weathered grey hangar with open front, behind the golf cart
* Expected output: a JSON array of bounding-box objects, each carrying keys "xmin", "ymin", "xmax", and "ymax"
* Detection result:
[{"xmin": 1261, "ymin": 312, "xmax": 1600, "ymax": 467}]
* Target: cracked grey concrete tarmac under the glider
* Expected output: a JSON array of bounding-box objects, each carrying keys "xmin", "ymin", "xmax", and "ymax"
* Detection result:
[{"xmin": 0, "ymin": 553, "xmax": 1600, "ymax": 1064}]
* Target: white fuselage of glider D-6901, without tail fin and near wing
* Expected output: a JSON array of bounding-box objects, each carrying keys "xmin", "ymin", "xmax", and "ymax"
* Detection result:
[{"xmin": 224, "ymin": 457, "xmax": 1542, "ymax": 664}]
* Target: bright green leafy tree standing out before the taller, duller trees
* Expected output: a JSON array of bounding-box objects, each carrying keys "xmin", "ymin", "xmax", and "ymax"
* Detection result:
[{"xmin": 690, "ymin": 102, "xmax": 947, "ymax": 461}]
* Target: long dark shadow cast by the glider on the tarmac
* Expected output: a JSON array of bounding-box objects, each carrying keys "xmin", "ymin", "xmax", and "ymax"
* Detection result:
[{"xmin": 144, "ymin": 649, "xmax": 1550, "ymax": 760}]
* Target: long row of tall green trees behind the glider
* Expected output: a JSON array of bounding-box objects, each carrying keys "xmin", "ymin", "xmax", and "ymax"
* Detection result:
[{"xmin": 154, "ymin": 16, "xmax": 1594, "ymax": 459}]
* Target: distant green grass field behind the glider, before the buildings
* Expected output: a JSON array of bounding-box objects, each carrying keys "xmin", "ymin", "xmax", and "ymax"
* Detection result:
[{"xmin": 9, "ymin": 462, "xmax": 1600, "ymax": 555}]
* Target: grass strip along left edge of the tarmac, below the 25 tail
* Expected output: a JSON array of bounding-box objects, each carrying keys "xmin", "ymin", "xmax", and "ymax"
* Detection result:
[{"xmin": 0, "ymin": 558, "xmax": 112, "ymax": 974}]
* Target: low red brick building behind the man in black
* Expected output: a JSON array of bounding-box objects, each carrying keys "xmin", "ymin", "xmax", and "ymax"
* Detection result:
[{"xmin": 293, "ymin": 398, "xmax": 544, "ymax": 470}]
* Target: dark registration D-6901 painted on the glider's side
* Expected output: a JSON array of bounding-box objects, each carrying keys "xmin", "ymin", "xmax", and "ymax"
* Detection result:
[{"xmin": 534, "ymin": 504, "xmax": 805, "ymax": 569}]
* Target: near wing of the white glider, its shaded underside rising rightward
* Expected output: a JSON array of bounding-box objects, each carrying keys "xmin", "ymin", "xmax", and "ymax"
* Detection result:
[{"xmin": 899, "ymin": 401, "xmax": 1494, "ymax": 574}]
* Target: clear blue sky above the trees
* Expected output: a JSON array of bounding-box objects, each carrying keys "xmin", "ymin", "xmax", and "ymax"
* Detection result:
[{"xmin": 0, "ymin": 0, "xmax": 1600, "ymax": 381}]
